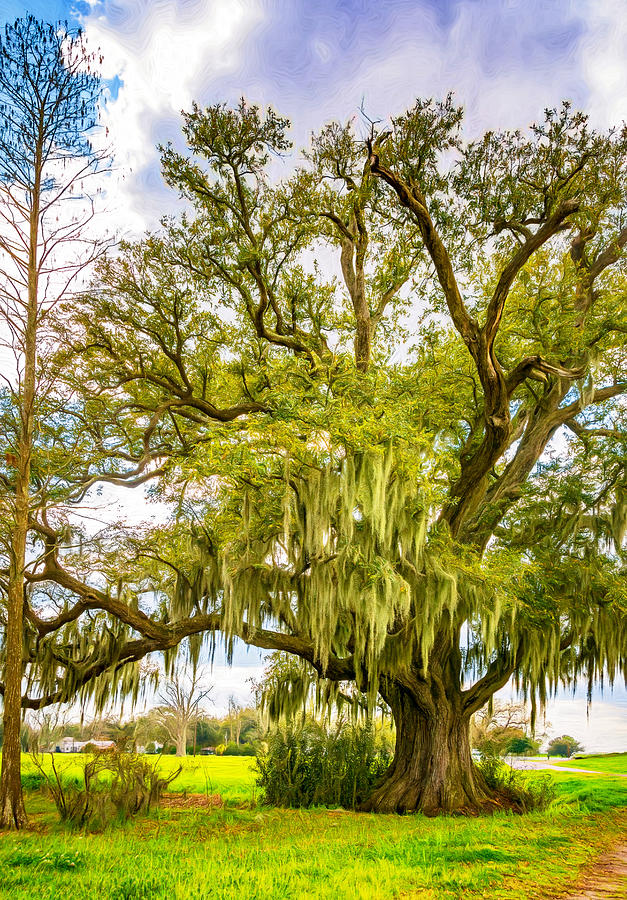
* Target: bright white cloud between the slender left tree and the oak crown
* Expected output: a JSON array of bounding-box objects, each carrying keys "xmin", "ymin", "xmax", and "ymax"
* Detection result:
[{"xmin": 83, "ymin": 0, "xmax": 261, "ymax": 234}]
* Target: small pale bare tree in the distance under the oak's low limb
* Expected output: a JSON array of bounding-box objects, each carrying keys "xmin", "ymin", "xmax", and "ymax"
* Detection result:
[{"xmin": 155, "ymin": 668, "xmax": 213, "ymax": 756}]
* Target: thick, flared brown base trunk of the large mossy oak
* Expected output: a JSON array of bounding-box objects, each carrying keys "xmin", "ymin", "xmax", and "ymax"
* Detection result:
[{"xmin": 362, "ymin": 679, "xmax": 495, "ymax": 816}]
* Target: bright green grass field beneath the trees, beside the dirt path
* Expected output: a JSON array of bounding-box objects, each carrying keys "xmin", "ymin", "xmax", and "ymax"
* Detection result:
[{"xmin": 0, "ymin": 757, "xmax": 627, "ymax": 900}]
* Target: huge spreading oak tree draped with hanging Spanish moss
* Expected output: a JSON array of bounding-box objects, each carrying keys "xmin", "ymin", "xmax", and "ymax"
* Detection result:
[{"xmin": 9, "ymin": 97, "xmax": 627, "ymax": 814}]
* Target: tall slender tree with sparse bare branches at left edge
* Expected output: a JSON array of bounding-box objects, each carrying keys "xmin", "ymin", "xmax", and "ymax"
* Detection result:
[{"xmin": 0, "ymin": 16, "xmax": 109, "ymax": 828}]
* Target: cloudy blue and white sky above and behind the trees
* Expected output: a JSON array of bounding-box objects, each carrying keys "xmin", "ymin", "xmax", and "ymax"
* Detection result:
[{"xmin": 0, "ymin": 0, "xmax": 627, "ymax": 750}]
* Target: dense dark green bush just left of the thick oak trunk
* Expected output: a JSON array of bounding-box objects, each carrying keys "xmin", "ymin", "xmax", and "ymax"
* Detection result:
[{"xmin": 257, "ymin": 720, "xmax": 391, "ymax": 809}]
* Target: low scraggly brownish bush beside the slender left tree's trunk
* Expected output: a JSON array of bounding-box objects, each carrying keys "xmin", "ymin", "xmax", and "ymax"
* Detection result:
[{"xmin": 32, "ymin": 750, "xmax": 182, "ymax": 828}]
